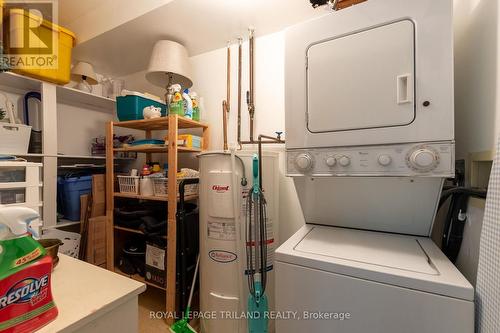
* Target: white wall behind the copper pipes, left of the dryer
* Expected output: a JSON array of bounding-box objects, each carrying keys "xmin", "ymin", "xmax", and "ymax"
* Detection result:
[{"xmin": 191, "ymin": 32, "xmax": 304, "ymax": 242}]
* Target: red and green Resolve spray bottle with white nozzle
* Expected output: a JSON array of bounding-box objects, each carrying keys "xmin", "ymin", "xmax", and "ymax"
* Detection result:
[{"xmin": 0, "ymin": 207, "xmax": 58, "ymax": 333}]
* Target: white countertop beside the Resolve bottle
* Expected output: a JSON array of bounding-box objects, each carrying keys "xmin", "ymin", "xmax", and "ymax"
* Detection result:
[{"xmin": 37, "ymin": 254, "xmax": 146, "ymax": 333}]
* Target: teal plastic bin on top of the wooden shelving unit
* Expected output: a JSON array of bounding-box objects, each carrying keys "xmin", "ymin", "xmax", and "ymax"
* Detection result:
[{"xmin": 116, "ymin": 91, "xmax": 167, "ymax": 121}]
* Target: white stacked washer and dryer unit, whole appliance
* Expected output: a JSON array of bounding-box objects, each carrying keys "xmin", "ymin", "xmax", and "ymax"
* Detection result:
[{"xmin": 275, "ymin": 0, "xmax": 474, "ymax": 333}]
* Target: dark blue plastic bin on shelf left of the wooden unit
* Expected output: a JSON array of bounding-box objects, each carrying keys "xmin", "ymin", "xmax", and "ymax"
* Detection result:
[{"xmin": 57, "ymin": 176, "xmax": 92, "ymax": 221}]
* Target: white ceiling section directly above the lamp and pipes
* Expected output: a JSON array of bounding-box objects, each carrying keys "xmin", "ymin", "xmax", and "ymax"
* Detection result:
[{"xmin": 71, "ymin": 0, "xmax": 326, "ymax": 76}]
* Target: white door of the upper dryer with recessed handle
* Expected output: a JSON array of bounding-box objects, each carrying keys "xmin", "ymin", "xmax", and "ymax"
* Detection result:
[{"xmin": 306, "ymin": 20, "xmax": 415, "ymax": 133}]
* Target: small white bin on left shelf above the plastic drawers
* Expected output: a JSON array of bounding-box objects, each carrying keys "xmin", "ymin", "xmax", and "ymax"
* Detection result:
[{"xmin": 0, "ymin": 123, "xmax": 31, "ymax": 155}]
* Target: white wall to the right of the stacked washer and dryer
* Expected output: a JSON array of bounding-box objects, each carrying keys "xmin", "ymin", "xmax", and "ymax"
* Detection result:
[{"xmin": 454, "ymin": 0, "xmax": 500, "ymax": 284}]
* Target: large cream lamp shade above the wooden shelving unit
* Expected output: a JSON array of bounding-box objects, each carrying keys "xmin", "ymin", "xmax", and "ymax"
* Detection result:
[{"xmin": 146, "ymin": 40, "xmax": 193, "ymax": 88}]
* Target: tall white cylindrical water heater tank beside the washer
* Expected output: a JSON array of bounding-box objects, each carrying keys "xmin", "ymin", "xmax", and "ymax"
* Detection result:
[{"xmin": 200, "ymin": 151, "xmax": 279, "ymax": 333}]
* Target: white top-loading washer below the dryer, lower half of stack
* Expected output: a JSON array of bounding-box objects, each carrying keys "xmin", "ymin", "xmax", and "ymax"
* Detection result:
[{"xmin": 276, "ymin": 224, "xmax": 474, "ymax": 333}]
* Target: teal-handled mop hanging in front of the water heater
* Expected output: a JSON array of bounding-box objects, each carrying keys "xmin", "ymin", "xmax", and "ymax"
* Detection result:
[{"xmin": 246, "ymin": 155, "xmax": 269, "ymax": 333}]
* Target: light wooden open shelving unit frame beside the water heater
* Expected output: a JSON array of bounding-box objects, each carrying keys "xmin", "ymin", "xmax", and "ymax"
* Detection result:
[{"xmin": 106, "ymin": 115, "xmax": 209, "ymax": 324}]
